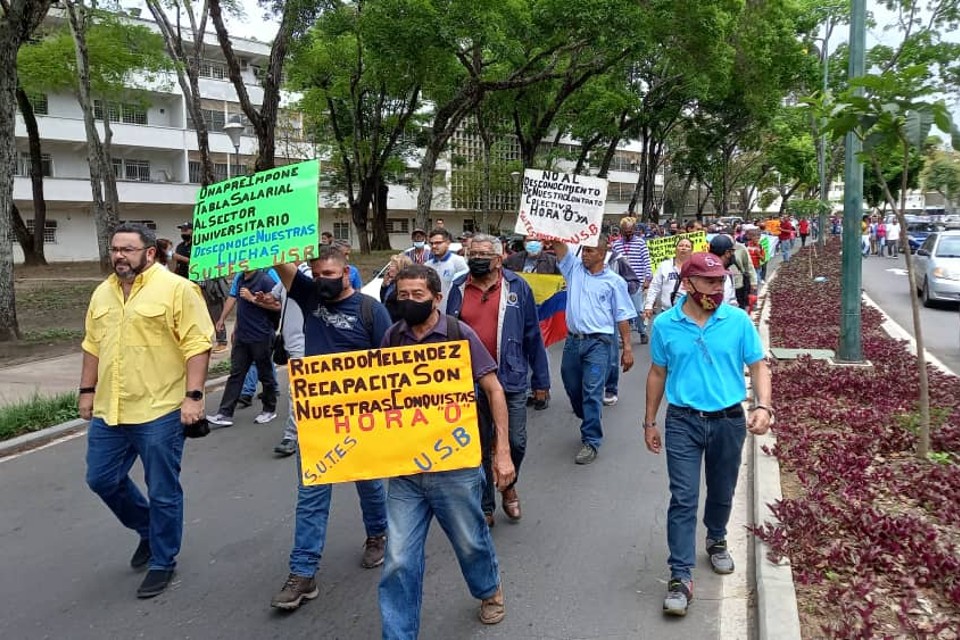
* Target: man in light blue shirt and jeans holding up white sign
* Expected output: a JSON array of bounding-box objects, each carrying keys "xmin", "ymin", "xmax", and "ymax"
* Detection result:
[{"xmin": 553, "ymin": 235, "xmax": 637, "ymax": 464}]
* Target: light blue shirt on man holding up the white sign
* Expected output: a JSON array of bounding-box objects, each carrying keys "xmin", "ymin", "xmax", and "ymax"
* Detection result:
[{"xmin": 557, "ymin": 251, "xmax": 637, "ymax": 335}]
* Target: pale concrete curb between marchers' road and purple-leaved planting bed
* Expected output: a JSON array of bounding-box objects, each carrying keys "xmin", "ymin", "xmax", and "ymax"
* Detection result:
[{"xmin": 749, "ymin": 272, "xmax": 800, "ymax": 640}]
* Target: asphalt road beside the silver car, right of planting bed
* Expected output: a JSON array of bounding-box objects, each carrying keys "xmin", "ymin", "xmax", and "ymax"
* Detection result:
[{"xmin": 863, "ymin": 256, "xmax": 960, "ymax": 374}]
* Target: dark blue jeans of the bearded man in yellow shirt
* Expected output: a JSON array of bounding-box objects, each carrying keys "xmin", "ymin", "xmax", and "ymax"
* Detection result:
[{"xmin": 87, "ymin": 409, "xmax": 183, "ymax": 569}]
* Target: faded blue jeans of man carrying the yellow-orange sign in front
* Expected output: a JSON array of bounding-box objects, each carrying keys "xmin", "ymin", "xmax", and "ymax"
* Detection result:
[{"xmin": 380, "ymin": 467, "xmax": 500, "ymax": 640}]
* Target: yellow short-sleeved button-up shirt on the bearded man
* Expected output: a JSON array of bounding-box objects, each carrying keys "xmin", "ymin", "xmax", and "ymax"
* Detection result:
[{"xmin": 83, "ymin": 264, "xmax": 214, "ymax": 425}]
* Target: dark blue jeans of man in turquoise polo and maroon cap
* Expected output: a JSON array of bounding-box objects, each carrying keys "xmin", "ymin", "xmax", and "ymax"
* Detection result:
[{"xmin": 663, "ymin": 406, "xmax": 747, "ymax": 580}]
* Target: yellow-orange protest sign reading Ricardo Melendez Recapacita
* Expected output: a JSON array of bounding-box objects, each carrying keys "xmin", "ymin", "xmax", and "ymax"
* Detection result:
[{"xmin": 287, "ymin": 340, "xmax": 480, "ymax": 485}]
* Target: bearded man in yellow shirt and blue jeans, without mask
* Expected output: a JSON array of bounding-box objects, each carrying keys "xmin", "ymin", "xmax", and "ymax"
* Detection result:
[{"xmin": 78, "ymin": 223, "xmax": 214, "ymax": 598}]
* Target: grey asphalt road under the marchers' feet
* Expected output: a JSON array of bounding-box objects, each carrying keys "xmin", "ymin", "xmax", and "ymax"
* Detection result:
[{"xmin": 0, "ymin": 338, "xmax": 740, "ymax": 640}]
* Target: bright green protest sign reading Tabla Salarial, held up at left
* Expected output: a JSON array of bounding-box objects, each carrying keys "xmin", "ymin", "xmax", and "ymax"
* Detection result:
[{"xmin": 190, "ymin": 160, "xmax": 320, "ymax": 281}]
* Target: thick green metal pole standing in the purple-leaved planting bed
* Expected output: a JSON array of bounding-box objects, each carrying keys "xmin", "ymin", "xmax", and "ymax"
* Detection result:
[{"xmin": 837, "ymin": 0, "xmax": 867, "ymax": 362}]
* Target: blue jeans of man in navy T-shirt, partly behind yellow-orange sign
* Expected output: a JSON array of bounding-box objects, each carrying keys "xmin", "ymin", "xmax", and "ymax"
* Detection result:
[{"xmin": 290, "ymin": 452, "xmax": 387, "ymax": 578}]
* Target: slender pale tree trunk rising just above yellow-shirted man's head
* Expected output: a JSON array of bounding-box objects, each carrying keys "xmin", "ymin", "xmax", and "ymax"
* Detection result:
[{"xmin": 64, "ymin": 1, "xmax": 118, "ymax": 273}]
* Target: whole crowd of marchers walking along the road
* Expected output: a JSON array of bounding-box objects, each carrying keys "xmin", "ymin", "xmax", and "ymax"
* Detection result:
[{"xmin": 79, "ymin": 217, "xmax": 772, "ymax": 638}]
